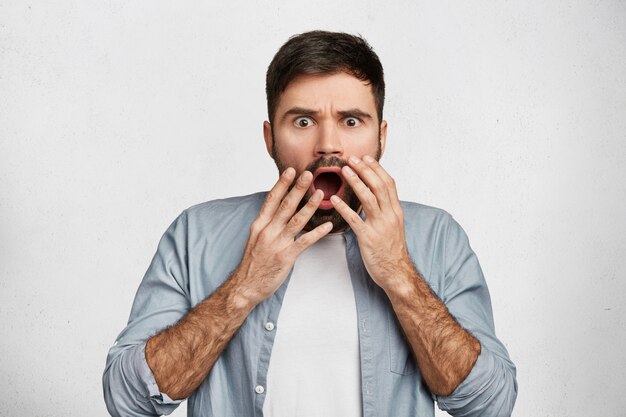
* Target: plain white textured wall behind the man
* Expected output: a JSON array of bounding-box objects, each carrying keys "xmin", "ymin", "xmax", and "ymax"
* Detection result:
[{"xmin": 0, "ymin": 0, "xmax": 626, "ymax": 417}]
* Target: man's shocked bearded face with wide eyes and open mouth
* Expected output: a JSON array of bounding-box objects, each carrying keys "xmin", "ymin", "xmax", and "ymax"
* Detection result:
[{"xmin": 263, "ymin": 73, "xmax": 387, "ymax": 231}]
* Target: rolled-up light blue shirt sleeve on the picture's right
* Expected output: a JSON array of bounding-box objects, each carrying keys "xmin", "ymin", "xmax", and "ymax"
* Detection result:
[{"xmin": 435, "ymin": 214, "xmax": 517, "ymax": 417}]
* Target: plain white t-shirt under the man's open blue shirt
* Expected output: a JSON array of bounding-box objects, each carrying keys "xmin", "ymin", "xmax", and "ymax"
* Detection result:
[{"xmin": 263, "ymin": 234, "xmax": 362, "ymax": 417}]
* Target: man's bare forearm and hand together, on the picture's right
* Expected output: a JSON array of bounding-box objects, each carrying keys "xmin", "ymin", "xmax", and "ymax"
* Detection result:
[{"xmin": 331, "ymin": 156, "xmax": 481, "ymax": 396}]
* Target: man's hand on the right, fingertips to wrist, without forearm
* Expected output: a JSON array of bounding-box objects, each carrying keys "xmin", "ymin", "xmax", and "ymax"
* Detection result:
[{"xmin": 331, "ymin": 156, "xmax": 414, "ymax": 291}]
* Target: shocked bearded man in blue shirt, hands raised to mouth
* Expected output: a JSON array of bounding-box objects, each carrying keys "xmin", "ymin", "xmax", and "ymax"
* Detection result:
[{"xmin": 104, "ymin": 31, "xmax": 517, "ymax": 417}]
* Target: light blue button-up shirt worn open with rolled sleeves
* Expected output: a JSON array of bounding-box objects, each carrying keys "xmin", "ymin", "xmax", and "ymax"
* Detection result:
[{"xmin": 103, "ymin": 193, "xmax": 517, "ymax": 417}]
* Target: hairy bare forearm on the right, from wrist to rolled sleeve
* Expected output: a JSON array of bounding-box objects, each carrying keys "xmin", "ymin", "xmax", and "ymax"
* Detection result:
[{"xmin": 386, "ymin": 261, "xmax": 481, "ymax": 396}]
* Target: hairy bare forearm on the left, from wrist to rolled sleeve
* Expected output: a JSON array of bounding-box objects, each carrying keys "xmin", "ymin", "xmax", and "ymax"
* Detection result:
[{"xmin": 146, "ymin": 271, "xmax": 255, "ymax": 399}]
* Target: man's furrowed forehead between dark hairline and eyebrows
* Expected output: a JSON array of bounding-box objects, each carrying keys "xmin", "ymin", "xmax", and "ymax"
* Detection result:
[{"xmin": 276, "ymin": 72, "xmax": 376, "ymax": 115}]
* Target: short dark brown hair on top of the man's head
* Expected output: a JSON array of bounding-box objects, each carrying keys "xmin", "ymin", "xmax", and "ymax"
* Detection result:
[{"xmin": 265, "ymin": 30, "xmax": 385, "ymax": 123}]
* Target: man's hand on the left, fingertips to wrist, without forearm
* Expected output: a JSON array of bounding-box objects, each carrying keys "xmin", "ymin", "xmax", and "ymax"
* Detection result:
[{"xmin": 232, "ymin": 168, "xmax": 332, "ymax": 305}]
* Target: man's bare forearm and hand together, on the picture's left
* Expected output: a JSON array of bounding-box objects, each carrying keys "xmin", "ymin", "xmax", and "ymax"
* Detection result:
[{"xmin": 145, "ymin": 168, "xmax": 332, "ymax": 399}]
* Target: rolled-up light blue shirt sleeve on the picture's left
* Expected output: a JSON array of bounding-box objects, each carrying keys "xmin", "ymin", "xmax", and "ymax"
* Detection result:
[{"xmin": 102, "ymin": 213, "xmax": 190, "ymax": 417}]
